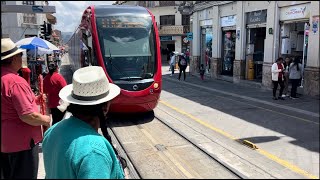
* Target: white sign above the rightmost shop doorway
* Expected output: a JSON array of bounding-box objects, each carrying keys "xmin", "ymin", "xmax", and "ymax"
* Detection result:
[{"xmin": 280, "ymin": 4, "xmax": 310, "ymax": 21}]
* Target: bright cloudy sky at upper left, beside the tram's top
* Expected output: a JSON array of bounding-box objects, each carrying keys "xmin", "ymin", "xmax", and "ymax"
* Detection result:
[{"xmin": 49, "ymin": 1, "xmax": 115, "ymax": 32}]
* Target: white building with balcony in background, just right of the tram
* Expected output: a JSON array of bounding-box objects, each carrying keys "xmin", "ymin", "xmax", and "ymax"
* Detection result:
[{"xmin": 116, "ymin": 1, "xmax": 192, "ymax": 62}]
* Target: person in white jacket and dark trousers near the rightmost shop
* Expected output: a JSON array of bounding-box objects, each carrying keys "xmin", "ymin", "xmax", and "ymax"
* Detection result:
[{"xmin": 271, "ymin": 57, "xmax": 284, "ymax": 100}]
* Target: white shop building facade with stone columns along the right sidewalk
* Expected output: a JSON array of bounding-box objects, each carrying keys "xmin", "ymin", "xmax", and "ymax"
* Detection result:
[{"xmin": 190, "ymin": 1, "xmax": 319, "ymax": 95}]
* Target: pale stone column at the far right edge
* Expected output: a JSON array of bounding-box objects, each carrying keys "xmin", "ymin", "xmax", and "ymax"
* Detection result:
[{"xmin": 303, "ymin": 1, "xmax": 320, "ymax": 96}]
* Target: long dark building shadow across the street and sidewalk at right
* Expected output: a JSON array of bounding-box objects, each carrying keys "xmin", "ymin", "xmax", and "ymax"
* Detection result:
[{"xmin": 162, "ymin": 69, "xmax": 319, "ymax": 152}]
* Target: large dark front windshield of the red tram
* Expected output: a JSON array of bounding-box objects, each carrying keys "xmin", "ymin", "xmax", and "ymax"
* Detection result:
[{"xmin": 97, "ymin": 16, "xmax": 156, "ymax": 81}]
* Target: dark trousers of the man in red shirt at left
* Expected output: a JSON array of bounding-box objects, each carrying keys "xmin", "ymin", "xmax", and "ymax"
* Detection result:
[{"xmin": 1, "ymin": 141, "xmax": 39, "ymax": 179}]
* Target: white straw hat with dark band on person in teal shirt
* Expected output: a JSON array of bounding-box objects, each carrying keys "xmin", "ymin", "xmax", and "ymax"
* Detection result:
[{"xmin": 59, "ymin": 66, "xmax": 120, "ymax": 105}]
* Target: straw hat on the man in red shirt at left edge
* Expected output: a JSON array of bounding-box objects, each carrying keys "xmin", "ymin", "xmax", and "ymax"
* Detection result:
[{"xmin": 1, "ymin": 38, "xmax": 24, "ymax": 61}]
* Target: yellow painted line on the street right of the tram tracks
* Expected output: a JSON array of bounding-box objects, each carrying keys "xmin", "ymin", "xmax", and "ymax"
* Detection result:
[{"xmin": 159, "ymin": 100, "xmax": 319, "ymax": 179}]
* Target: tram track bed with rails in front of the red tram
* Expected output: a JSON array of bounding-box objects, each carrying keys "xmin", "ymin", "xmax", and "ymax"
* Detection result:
[{"xmin": 110, "ymin": 112, "xmax": 244, "ymax": 179}]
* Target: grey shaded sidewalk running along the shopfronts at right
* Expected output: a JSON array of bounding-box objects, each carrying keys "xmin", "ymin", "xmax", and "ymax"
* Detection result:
[{"xmin": 162, "ymin": 66, "xmax": 320, "ymax": 118}]
